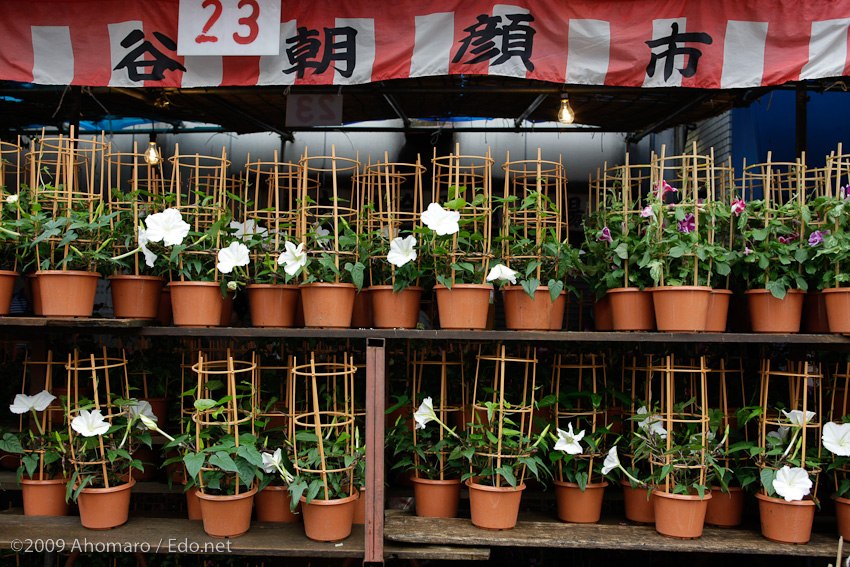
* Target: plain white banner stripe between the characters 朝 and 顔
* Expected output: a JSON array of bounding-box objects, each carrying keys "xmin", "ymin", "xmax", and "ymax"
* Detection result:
[{"xmin": 410, "ymin": 12, "xmax": 455, "ymax": 77}]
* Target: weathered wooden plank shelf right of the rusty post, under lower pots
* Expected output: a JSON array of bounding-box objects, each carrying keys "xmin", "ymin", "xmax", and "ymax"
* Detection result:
[{"xmin": 384, "ymin": 511, "xmax": 850, "ymax": 559}]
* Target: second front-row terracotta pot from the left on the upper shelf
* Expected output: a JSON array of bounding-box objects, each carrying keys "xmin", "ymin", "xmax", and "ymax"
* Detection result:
[{"xmin": 36, "ymin": 270, "xmax": 100, "ymax": 317}]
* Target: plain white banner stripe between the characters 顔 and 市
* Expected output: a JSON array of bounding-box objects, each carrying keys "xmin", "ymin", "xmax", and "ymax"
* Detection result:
[{"xmin": 564, "ymin": 20, "xmax": 611, "ymax": 85}]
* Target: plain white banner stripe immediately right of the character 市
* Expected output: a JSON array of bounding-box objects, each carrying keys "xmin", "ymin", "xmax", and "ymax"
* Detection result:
[{"xmin": 720, "ymin": 20, "xmax": 767, "ymax": 89}]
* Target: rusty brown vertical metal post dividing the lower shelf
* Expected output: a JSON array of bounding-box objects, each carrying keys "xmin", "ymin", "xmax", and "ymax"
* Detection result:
[{"xmin": 363, "ymin": 339, "xmax": 386, "ymax": 565}]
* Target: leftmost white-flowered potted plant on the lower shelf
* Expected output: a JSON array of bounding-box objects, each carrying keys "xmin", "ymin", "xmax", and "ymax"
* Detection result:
[{"xmin": 0, "ymin": 390, "xmax": 68, "ymax": 516}]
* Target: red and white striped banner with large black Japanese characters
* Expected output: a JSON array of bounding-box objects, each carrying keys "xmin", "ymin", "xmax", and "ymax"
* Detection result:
[{"xmin": 0, "ymin": 0, "xmax": 850, "ymax": 88}]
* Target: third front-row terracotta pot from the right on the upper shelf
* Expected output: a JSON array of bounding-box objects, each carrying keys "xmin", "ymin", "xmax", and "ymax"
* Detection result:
[{"xmin": 652, "ymin": 285, "xmax": 711, "ymax": 333}]
